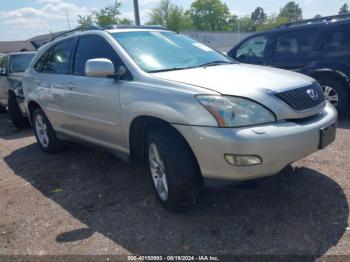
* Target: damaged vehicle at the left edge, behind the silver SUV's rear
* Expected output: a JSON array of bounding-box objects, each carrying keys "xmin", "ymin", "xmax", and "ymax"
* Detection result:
[{"xmin": 0, "ymin": 52, "xmax": 35, "ymax": 128}]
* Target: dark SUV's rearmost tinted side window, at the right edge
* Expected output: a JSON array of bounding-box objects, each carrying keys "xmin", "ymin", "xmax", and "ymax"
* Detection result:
[{"xmin": 326, "ymin": 24, "xmax": 350, "ymax": 52}]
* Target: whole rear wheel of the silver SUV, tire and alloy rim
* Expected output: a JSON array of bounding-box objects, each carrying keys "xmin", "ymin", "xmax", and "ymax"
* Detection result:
[{"xmin": 33, "ymin": 108, "xmax": 64, "ymax": 154}]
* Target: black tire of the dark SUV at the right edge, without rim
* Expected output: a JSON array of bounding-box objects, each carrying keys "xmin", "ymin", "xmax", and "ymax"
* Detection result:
[{"xmin": 317, "ymin": 76, "xmax": 350, "ymax": 118}]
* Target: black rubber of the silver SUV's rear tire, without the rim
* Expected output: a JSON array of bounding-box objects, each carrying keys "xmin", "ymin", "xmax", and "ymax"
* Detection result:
[{"xmin": 33, "ymin": 108, "xmax": 64, "ymax": 154}]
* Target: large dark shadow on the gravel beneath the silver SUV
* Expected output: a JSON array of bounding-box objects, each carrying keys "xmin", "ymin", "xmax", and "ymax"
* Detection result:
[{"xmin": 5, "ymin": 145, "xmax": 349, "ymax": 256}]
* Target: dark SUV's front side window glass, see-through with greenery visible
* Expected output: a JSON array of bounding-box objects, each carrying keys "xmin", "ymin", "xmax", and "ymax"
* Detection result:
[{"xmin": 236, "ymin": 36, "xmax": 268, "ymax": 61}]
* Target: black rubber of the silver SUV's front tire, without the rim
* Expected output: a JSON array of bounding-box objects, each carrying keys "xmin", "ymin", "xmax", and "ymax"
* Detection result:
[{"xmin": 145, "ymin": 127, "xmax": 202, "ymax": 211}]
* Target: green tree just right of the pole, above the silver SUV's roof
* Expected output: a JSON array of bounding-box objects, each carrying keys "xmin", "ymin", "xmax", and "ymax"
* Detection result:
[{"xmin": 146, "ymin": 0, "xmax": 192, "ymax": 31}]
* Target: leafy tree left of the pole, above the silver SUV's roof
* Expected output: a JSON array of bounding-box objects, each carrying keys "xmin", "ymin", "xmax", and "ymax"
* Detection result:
[{"xmin": 78, "ymin": 0, "xmax": 132, "ymax": 26}]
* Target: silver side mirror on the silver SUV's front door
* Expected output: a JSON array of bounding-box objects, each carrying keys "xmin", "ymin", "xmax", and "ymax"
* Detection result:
[{"xmin": 85, "ymin": 58, "xmax": 115, "ymax": 77}]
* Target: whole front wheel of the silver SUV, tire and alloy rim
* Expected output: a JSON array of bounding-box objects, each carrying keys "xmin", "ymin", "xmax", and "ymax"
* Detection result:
[{"xmin": 146, "ymin": 128, "xmax": 201, "ymax": 211}]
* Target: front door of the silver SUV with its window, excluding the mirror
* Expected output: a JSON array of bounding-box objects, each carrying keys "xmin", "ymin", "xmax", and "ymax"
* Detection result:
[{"xmin": 64, "ymin": 35, "xmax": 126, "ymax": 150}]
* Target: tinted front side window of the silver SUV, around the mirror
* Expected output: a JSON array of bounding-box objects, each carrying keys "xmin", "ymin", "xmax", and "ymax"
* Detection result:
[{"xmin": 73, "ymin": 35, "xmax": 122, "ymax": 76}]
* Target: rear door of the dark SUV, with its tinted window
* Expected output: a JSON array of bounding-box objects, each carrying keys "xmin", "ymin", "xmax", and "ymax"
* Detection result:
[{"xmin": 266, "ymin": 28, "xmax": 322, "ymax": 71}]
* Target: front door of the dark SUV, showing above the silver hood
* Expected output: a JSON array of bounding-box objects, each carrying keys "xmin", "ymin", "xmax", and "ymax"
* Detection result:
[{"xmin": 230, "ymin": 35, "xmax": 270, "ymax": 65}]
